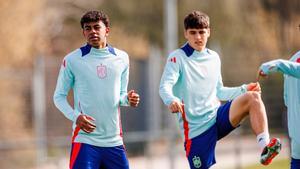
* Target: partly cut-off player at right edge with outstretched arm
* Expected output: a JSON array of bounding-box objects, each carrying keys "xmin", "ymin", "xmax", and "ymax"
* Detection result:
[{"xmin": 259, "ymin": 25, "xmax": 300, "ymax": 169}]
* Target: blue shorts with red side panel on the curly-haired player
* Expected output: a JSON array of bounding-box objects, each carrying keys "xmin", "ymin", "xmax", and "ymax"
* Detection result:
[{"xmin": 70, "ymin": 143, "xmax": 129, "ymax": 169}]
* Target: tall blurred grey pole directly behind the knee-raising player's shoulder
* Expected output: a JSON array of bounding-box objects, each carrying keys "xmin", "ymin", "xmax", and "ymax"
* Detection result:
[{"xmin": 164, "ymin": 0, "xmax": 178, "ymax": 169}]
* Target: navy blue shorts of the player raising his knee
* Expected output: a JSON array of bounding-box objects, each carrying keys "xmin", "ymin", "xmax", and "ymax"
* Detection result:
[{"xmin": 185, "ymin": 102, "xmax": 235, "ymax": 169}]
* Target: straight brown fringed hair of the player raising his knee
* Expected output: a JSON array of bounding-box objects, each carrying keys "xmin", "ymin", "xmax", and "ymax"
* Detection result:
[{"xmin": 184, "ymin": 11, "xmax": 209, "ymax": 30}]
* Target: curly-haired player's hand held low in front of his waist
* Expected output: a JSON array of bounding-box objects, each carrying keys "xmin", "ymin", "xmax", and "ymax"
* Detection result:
[{"xmin": 76, "ymin": 114, "xmax": 96, "ymax": 133}]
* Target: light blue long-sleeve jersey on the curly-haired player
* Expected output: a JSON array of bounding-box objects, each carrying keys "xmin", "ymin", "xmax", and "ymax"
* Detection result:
[{"xmin": 53, "ymin": 45, "xmax": 129, "ymax": 147}]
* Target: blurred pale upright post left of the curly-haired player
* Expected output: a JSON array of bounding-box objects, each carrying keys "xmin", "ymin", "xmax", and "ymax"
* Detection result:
[{"xmin": 32, "ymin": 57, "xmax": 47, "ymax": 168}]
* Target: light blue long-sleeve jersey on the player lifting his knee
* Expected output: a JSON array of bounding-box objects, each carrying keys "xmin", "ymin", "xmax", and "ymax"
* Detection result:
[{"xmin": 159, "ymin": 43, "xmax": 247, "ymax": 140}]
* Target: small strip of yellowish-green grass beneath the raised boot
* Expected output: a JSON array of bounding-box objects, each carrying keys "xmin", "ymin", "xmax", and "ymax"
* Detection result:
[{"xmin": 244, "ymin": 159, "xmax": 290, "ymax": 169}]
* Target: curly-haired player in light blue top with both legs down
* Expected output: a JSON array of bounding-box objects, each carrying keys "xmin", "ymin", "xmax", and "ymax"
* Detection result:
[{"xmin": 53, "ymin": 11, "xmax": 139, "ymax": 169}]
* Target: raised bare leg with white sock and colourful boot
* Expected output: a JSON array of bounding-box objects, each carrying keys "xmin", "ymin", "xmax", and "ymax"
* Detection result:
[{"xmin": 229, "ymin": 91, "xmax": 281, "ymax": 165}]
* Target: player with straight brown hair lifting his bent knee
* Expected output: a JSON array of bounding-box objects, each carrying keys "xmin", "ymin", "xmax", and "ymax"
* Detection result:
[{"xmin": 159, "ymin": 11, "xmax": 281, "ymax": 169}]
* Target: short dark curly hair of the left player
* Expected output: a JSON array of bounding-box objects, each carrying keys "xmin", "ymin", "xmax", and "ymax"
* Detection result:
[{"xmin": 80, "ymin": 11, "xmax": 109, "ymax": 28}]
